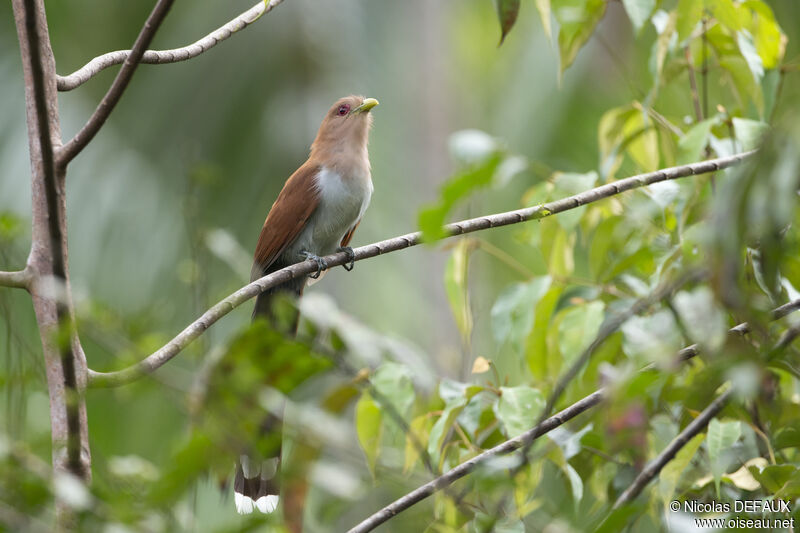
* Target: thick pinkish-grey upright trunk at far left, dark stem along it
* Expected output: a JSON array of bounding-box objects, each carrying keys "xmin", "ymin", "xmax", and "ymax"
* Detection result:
[{"xmin": 13, "ymin": 0, "xmax": 90, "ymax": 481}]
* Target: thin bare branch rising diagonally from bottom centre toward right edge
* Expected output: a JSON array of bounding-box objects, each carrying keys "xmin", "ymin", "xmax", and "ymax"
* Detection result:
[{"xmin": 347, "ymin": 299, "xmax": 800, "ymax": 533}]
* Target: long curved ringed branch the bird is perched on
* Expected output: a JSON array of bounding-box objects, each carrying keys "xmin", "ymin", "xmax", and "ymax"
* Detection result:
[{"xmin": 89, "ymin": 150, "xmax": 756, "ymax": 387}]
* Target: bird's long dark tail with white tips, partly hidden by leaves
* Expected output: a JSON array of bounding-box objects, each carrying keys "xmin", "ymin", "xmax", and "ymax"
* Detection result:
[{"xmin": 233, "ymin": 265, "xmax": 306, "ymax": 514}]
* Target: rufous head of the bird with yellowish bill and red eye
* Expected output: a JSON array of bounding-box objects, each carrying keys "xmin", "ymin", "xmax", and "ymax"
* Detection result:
[{"xmin": 311, "ymin": 96, "xmax": 378, "ymax": 158}]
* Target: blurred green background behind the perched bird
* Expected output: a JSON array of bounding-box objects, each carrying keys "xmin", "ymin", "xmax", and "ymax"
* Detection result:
[{"xmin": 0, "ymin": 0, "xmax": 800, "ymax": 531}]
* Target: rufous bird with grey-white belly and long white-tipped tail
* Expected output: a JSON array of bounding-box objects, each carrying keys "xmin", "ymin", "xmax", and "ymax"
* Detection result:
[{"xmin": 234, "ymin": 95, "xmax": 378, "ymax": 514}]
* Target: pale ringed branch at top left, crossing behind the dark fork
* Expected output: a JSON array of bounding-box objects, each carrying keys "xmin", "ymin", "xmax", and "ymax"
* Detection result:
[{"xmin": 56, "ymin": 0, "xmax": 283, "ymax": 91}]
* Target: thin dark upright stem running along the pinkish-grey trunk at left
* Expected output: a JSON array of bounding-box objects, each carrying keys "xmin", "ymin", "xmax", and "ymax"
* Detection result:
[{"xmin": 23, "ymin": 0, "xmax": 87, "ymax": 478}]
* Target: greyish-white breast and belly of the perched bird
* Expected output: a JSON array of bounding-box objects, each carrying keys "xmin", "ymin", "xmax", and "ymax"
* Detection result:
[{"xmin": 287, "ymin": 167, "xmax": 372, "ymax": 261}]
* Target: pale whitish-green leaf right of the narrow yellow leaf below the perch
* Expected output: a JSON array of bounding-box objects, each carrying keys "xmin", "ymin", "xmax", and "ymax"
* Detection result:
[{"xmin": 491, "ymin": 276, "xmax": 550, "ymax": 344}]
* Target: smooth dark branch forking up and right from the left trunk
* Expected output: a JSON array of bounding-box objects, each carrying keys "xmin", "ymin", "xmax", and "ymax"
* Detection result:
[{"xmin": 57, "ymin": 0, "xmax": 174, "ymax": 167}]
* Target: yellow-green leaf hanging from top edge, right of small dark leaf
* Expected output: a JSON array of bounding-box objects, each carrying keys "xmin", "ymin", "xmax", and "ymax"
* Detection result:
[{"xmin": 551, "ymin": 0, "xmax": 606, "ymax": 76}]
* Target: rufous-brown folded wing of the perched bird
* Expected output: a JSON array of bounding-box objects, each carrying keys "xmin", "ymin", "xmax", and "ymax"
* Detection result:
[{"xmin": 250, "ymin": 163, "xmax": 319, "ymax": 281}]
